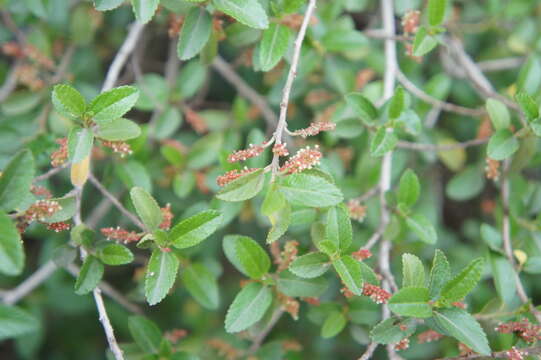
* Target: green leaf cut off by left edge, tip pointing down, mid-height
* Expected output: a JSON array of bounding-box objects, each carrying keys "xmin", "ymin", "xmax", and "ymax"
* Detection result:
[{"xmin": 0, "ymin": 212, "xmax": 25, "ymax": 276}]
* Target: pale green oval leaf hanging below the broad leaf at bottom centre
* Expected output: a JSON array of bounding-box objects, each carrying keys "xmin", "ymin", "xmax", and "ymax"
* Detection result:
[{"xmin": 225, "ymin": 283, "xmax": 272, "ymax": 333}]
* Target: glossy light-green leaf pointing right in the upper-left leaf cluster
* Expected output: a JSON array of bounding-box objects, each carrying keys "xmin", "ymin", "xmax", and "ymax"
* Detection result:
[{"xmin": 87, "ymin": 86, "xmax": 139, "ymax": 124}]
